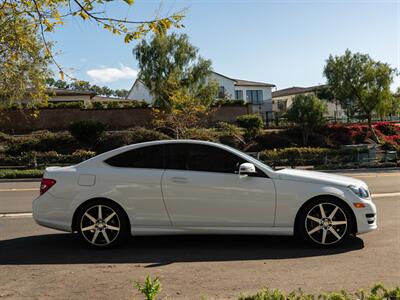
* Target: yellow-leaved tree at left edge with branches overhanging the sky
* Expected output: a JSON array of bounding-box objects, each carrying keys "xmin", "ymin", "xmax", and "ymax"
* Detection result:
[{"xmin": 0, "ymin": 0, "xmax": 183, "ymax": 106}]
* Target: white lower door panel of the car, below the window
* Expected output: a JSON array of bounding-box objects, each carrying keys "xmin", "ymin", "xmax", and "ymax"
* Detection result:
[{"xmin": 162, "ymin": 170, "xmax": 276, "ymax": 227}]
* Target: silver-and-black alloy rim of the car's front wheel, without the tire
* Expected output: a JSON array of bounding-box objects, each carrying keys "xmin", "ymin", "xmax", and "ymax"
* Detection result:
[{"xmin": 305, "ymin": 203, "xmax": 348, "ymax": 245}]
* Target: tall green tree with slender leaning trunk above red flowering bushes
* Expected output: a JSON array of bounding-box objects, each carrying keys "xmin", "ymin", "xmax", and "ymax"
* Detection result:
[{"xmin": 324, "ymin": 50, "xmax": 395, "ymax": 142}]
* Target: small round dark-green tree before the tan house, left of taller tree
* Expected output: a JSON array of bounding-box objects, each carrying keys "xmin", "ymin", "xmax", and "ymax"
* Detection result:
[{"xmin": 286, "ymin": 95, "xmax": 327, "ymax": 146}]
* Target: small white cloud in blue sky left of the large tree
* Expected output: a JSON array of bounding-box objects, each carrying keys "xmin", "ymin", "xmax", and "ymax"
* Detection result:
[{"xmin": 86, "ymin": 64, "xmax": 138, "ymax": 83}]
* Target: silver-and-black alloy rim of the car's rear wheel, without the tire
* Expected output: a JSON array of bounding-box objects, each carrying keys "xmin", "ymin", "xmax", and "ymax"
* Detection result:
[{"xmin": 80, "ymin": 204, "xmax": 121, "ymax": 246}]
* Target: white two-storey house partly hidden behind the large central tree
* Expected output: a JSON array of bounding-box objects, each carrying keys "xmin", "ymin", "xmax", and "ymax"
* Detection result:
[{"xmin": 126, "ymin": 72, "xmax": 275, "ymax": 121}]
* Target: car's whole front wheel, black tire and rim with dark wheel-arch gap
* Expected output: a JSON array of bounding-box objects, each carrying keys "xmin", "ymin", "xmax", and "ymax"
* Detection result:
[{"xmin": 295, "ymin": 197, "xmax": 354, "ymax": 248}]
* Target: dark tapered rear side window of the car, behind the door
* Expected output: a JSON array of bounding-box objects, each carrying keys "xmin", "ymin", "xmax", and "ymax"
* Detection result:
[{"xmin": 104, "ymin": 145, "xmax": 164, "ymax": 169}]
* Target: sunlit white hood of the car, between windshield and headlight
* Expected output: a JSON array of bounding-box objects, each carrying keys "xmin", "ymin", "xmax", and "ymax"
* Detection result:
[{"xmin": 276, "ymin": 169, "xmax": 368, "ymax": 188}]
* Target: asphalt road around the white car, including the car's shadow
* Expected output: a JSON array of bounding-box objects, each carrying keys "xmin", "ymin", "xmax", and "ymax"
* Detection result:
[{"xmin": 0, "ymin": 172, "xmax": 400, "ymax": 299}]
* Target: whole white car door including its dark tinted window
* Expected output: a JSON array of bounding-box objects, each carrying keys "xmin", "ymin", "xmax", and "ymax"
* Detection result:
[{"xmin": 162, "ymin": 143, "xmax": 275, "ymax": 227}]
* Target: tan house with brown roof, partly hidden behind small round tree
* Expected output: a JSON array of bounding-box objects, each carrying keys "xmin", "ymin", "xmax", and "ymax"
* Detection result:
[{"xmin": 272, "ymin": 85, "xmax": 345, "ymax": 119}]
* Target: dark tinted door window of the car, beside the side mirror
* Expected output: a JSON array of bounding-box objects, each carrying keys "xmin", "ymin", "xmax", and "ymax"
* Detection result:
[{"xmin": 166, "ymin": 144, "xmax": 245, "ymax": 174}]
